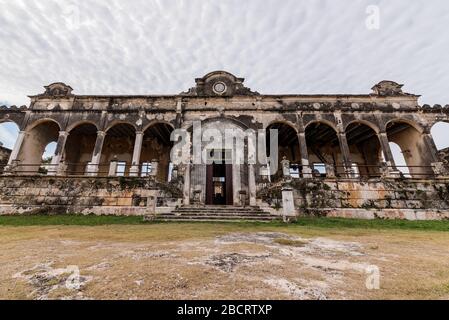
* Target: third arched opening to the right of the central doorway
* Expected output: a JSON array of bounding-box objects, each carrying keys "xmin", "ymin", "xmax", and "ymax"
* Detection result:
[{"xmin": 346, "ymin": 122, "xmax": 382, "ymax": 178}]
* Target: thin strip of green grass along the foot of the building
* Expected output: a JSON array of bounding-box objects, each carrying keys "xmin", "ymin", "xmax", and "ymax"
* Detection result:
[{"xmin": 0, "ymin": 215, "xmax": 449, "ymax": 231}]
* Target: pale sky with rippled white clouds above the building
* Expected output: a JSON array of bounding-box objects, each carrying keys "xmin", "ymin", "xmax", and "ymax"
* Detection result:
[{"xmin": 0, "ymin": 0, "xmax": 449, "ymax": 154}]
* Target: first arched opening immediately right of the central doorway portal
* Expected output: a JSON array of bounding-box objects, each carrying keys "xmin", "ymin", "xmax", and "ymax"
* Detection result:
[{"xmin": 266, "ymin": 122, "xmax": 302, "ymax": 178}]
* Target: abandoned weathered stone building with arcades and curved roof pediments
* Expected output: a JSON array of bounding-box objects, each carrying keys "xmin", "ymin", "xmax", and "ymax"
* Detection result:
[{"xmin": 0, "ymin": 71, "xmax": 449, "ymax": 220}]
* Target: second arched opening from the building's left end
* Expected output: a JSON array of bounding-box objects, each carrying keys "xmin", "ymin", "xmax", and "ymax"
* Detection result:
[{"xmin": 63, "ymin": 123, "xmax": 97, "ymax": 175}]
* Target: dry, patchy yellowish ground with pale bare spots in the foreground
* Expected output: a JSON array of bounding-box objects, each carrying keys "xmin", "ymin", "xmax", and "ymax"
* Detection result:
[{"xmin": 0, "ymin": 223, "xmax": 449, "ymax": 299}]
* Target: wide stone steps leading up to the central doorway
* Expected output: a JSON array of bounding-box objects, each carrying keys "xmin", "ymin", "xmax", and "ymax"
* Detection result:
[{"xmin": 145, "ymin": 206, "xmax": 280, "ymax": 222}]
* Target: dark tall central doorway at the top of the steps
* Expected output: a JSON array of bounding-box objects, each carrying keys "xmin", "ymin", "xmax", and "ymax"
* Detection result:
[{"xmin": 206, "ymin": 151, "xmax": 233, "ymax": 205}]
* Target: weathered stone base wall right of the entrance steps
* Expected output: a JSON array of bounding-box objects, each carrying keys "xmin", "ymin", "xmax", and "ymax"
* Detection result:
[{"xmin": 258, "ymin": 179, "xmax": 449, "ymax": 219}]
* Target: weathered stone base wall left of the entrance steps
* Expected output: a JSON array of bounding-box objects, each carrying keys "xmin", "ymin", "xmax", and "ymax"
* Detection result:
[{"xmin": 0, "ymin": 176, "xmax": 180, "ymax": 215}]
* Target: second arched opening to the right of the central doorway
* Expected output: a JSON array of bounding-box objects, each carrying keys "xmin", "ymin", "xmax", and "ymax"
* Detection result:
[{"xmin": 305, "ymin": 122, "xmax": 345, "ymax": 176}]
